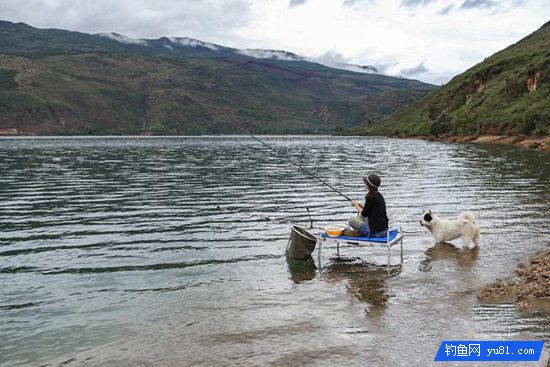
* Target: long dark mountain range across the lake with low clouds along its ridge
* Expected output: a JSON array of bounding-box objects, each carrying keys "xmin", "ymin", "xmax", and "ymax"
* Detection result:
[{"xmin": 0, "ymin": 21, "xmax": 435, "ymax": 135}]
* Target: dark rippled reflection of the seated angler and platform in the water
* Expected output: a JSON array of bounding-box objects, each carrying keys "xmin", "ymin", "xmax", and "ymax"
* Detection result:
[{"xmin": 324, "ymin": 258, "xmax": 402, "ymax": 316}]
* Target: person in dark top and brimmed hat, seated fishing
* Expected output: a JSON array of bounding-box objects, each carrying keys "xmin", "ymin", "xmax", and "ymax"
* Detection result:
[{"xmin": 343, "ymin": 174, "xmax": 388, "ymax": 237}]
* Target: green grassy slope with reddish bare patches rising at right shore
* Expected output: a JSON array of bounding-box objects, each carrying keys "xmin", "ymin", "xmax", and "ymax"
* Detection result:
[{"xmin": 352, "ymin": 22, "xmax": 550, "ymax": 135}]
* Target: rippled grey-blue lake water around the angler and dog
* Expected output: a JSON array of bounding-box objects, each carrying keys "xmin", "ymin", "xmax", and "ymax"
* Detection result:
[{"xmin": 0, "ymin": 137, "xmax": 550, "ymax": 366}]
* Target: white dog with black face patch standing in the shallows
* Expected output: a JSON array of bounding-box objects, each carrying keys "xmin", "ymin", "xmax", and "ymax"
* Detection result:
[{"xmin": 420, "ymin": 210, "xmax": 479, "ymax": 249}]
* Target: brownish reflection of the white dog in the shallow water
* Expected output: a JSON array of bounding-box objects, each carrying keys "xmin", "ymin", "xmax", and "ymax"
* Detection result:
[{"xmin": 418, "ymin": 242, "xmax": 479, "ymax": 271}]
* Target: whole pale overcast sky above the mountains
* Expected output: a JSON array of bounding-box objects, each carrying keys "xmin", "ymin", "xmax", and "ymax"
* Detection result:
[{"xmin": 0, "ymin": 0, "xmax": 550, "ymax": 84}]
